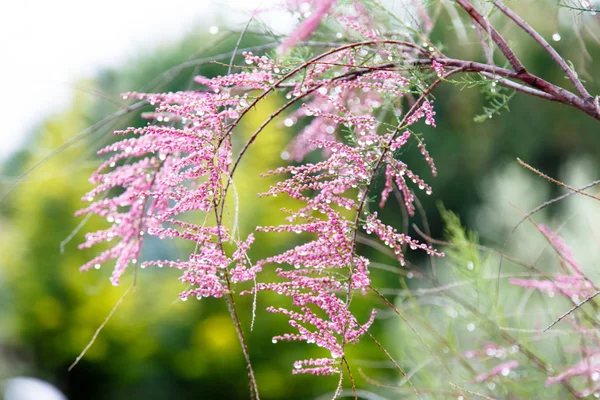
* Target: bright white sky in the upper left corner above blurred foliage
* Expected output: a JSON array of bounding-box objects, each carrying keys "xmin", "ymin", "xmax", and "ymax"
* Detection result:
[{"xmin": 0, "ymin": 0, "xmax": 289, "ymax": 161}]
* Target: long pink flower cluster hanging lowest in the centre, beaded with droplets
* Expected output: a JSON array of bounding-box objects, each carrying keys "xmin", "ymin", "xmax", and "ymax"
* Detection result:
[{"xmin": 257, "ymin": 141, "xmax": 375, "ymax": 374}]
